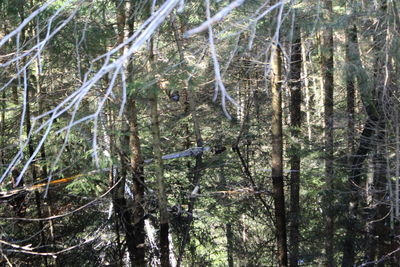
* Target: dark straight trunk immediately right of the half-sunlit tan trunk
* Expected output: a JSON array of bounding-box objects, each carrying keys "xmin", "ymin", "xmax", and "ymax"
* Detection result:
[{"xmin": 289, "ymin": 18, "xmax": 302, "ymax": 266}]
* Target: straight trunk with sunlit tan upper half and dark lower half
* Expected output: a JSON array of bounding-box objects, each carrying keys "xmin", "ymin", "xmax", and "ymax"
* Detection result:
[{"xmin": 271, "ymin": 44, "xmax": 288, "ymax": 266}]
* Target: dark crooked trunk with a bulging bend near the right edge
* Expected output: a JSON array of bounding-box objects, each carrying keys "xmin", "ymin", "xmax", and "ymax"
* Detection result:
[{"xmin": 342, "ymin": 13, "xmax": 386, "ymax": 267}]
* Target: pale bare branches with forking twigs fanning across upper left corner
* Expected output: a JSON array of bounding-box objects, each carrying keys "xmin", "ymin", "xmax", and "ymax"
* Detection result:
[{"xmin": 0, "ymin": 0, "xmax": 180, "ymax": 184}]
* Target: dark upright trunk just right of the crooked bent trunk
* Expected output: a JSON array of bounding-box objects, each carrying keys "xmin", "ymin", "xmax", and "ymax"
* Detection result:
[{"xmin": 369, "ymin": 0, "xmax": 391, "ymax": 266}]
